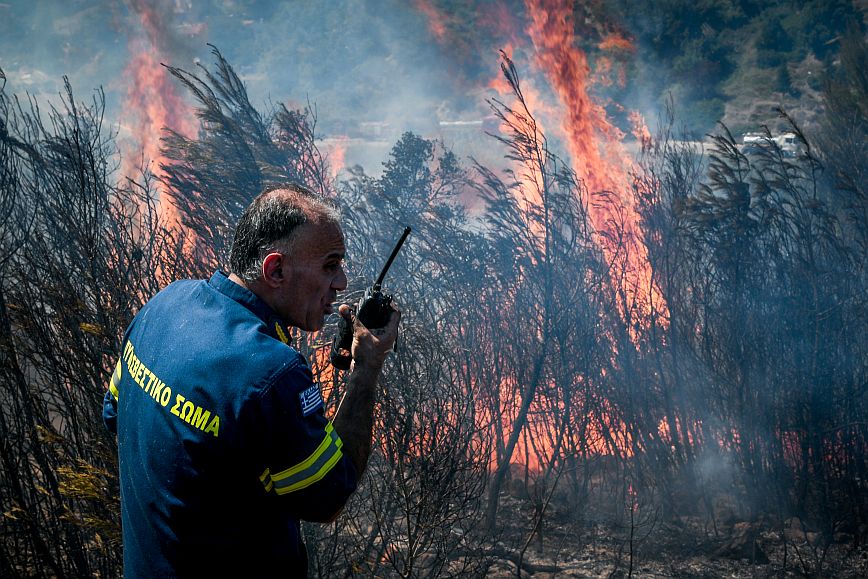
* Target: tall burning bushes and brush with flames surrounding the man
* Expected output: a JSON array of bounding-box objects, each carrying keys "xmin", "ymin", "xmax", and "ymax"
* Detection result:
[{"xmin": 0, "ymin": 0, "xmax": 868, "ymax": 577}]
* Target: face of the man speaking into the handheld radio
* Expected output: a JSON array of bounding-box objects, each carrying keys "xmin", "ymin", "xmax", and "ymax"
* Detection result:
[{"xmin": 275, "ymin": 222, "xmax": 347, "ymax": 331}]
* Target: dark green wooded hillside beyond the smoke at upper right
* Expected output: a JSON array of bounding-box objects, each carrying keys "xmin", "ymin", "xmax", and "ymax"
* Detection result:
[{"xmin": 614, "ymin": 0, "xmax": 868, "ymax": 133}]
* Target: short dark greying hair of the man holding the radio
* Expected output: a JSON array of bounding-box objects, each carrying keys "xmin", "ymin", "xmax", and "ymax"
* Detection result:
[{"xmin": 229, "ymin": 183, "xmax": 340, "ymax": 282}]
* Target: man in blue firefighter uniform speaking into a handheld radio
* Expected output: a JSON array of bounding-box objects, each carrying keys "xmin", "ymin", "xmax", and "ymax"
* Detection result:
[{"xmin": 104, "ymin": 185, "xmax": 400, "ymax": 577}]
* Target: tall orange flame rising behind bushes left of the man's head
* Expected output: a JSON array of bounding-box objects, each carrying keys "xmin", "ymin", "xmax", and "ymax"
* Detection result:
[{"xmin": 121, "ymin": 0, "xmax": 197, "ymax": 236}]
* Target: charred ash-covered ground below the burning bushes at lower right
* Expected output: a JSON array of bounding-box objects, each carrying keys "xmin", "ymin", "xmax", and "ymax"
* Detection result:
[{"xmin": 474, "ymin": 478, "xmax": 868, "ymax": 579}]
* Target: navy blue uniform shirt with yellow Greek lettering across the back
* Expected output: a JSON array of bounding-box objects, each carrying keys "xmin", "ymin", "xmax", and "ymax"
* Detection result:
[{"xmin": 103, "ymin": 272, "xmax": 357, "ymax": 578}]
